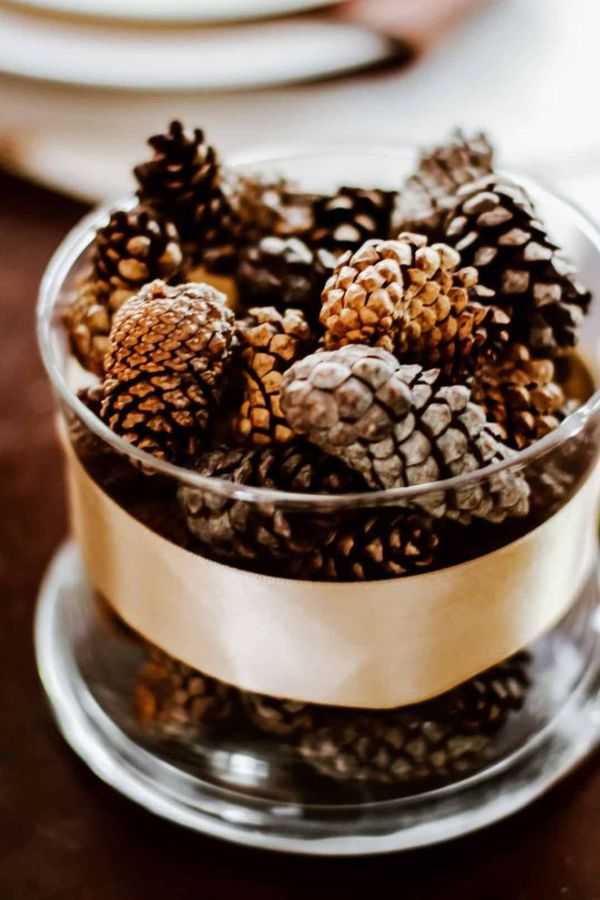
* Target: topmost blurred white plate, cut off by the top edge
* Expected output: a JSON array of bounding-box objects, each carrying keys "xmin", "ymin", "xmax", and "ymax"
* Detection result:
[{"xmin": 2, "ymin": 0, "xmax": 336, "ymax": 22}]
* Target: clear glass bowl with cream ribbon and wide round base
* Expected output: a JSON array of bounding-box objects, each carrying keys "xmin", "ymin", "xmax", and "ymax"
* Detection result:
[{"xmin": 36, "ymin": 150, "xmax": 600, "ymax": 855}]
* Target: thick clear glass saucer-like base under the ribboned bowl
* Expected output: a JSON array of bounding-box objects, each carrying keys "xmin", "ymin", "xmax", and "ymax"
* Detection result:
[{"xmin": 35, "ymin": 543, "xmax": 600, "ymax": 856}]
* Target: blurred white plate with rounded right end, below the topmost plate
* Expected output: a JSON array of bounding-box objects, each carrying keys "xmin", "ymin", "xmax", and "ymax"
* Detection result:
[{"xmin": 0, "ymin": 6, "xmax": 390, "ymax": 90}]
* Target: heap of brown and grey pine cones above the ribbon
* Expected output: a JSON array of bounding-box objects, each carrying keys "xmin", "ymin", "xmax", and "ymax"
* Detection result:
[{"xmin": 65, "ymin": 122, "xmax": 590, "ymax": 580}]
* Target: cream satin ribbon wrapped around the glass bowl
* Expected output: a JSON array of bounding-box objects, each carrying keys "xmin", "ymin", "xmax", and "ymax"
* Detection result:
[{"xmin": 67, "ymin": 445, "xmax": 597, "ymax": 709}]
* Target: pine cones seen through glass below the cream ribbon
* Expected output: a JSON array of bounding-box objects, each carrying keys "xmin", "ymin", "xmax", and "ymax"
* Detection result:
[{"xmin": 134, "ymin": 645, "xmax": 532, "ymax": 787}]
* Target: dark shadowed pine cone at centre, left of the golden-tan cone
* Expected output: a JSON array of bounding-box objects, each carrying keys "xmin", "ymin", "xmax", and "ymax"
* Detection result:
[{"xmin": 237, "ymin": 236, "xmax": 335, "ymax": 322}]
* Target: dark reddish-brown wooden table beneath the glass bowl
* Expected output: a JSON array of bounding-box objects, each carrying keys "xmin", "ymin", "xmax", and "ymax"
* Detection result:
[{"xmin": 0, "ymin": 174, "xmax": 600, "ymax": 900}]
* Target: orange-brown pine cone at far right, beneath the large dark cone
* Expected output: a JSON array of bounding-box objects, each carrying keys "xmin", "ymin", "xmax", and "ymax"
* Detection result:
[{"xmin": 471, "ymin": 344, "xmax": 568, "ymax": 450}]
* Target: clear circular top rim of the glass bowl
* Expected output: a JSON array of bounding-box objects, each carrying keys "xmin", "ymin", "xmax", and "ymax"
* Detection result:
[{"xmin": 36, "ymin": 147, "xmax": 600, "ymax": 509}]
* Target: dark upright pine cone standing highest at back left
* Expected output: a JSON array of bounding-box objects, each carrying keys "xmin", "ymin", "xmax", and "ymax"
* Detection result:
[{"xmin": 134, "ymin": 121, "xmax": 221, "ymax": 241}]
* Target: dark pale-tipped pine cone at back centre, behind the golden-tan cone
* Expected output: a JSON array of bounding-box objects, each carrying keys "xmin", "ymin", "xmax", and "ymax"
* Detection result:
[{"xmin": 308, "ymin": 187, "xmax": 396, "ymax": 254}]
